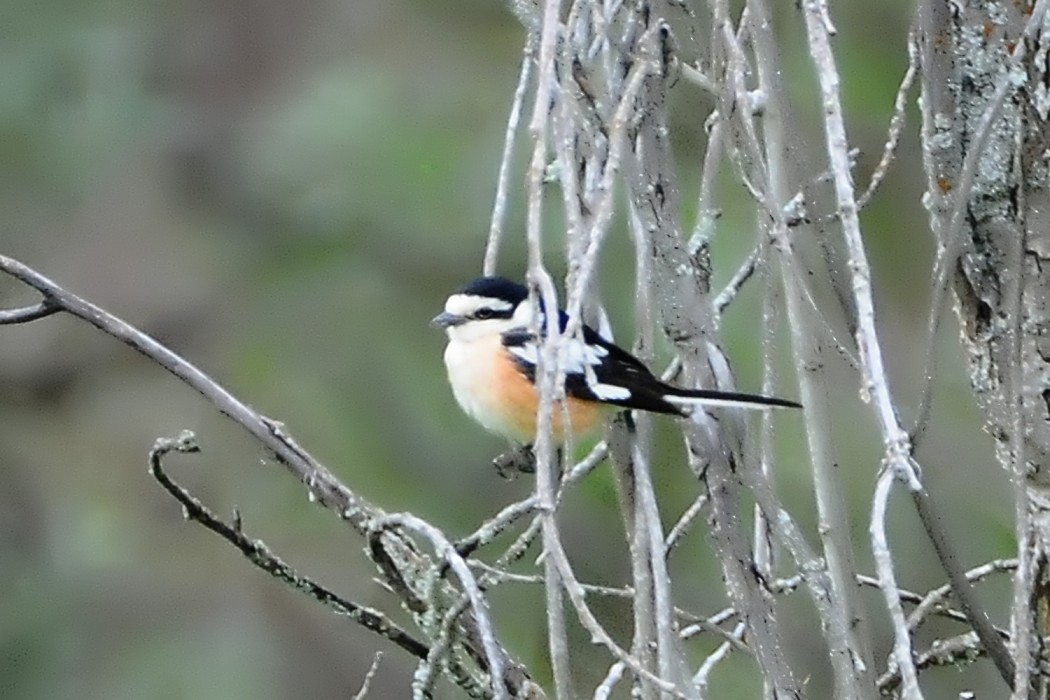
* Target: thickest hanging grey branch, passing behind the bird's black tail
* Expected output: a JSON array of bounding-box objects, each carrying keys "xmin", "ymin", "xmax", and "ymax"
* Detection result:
[{"xmin": 627, "ymin": 5, "xmax": 800, "ymax": 698}]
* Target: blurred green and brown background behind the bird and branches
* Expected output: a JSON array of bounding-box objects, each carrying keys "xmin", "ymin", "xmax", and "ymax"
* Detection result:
[{"xmin": 0, "ymin": 0, "xmax": 1012, "ymax": 700}]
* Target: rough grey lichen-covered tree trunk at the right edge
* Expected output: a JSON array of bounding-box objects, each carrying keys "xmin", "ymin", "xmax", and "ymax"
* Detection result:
[{"xmin": 921, "ymin": 2, "xmax": 1050, "ymax": 698}]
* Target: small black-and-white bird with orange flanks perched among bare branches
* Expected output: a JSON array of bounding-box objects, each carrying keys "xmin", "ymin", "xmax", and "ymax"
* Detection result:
[{"xmin": 431, "ymin": 276, "xmax": 802, "ymax": 445}]
